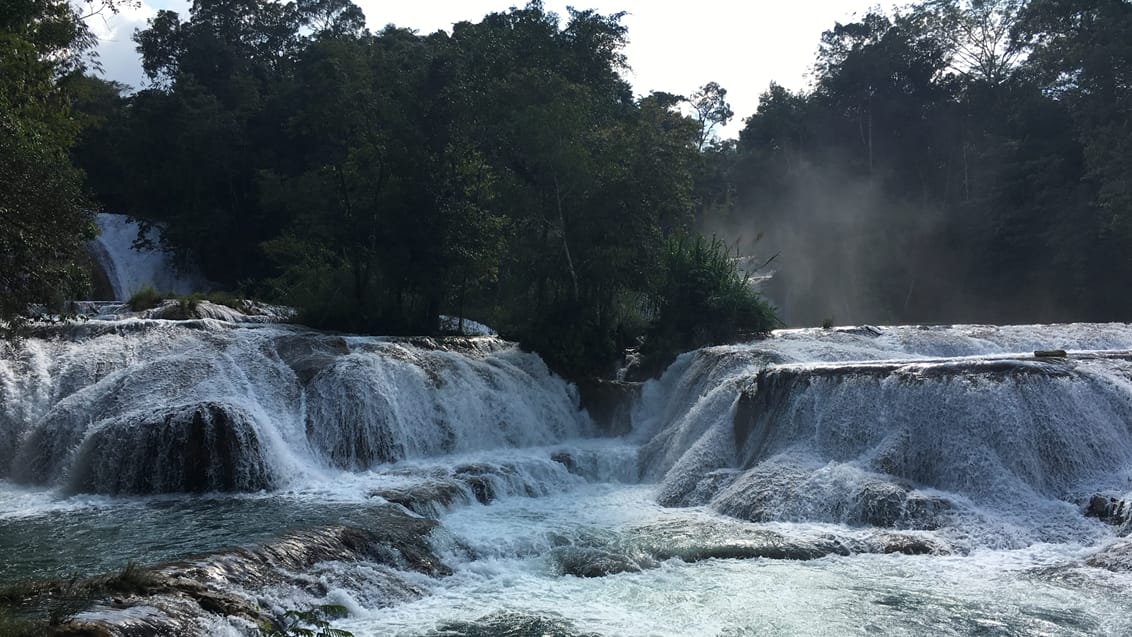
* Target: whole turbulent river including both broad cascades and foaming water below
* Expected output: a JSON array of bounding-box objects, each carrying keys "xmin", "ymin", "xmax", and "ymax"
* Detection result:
[{"xmin": 0, "ymin": 316, "xmax": 1132, "ymax": 636}]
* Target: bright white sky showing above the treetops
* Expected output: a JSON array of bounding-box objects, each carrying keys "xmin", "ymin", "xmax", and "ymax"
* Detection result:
[{"xmin": 93, "ymin": 0, "xmax": 890, "ymax": 137}]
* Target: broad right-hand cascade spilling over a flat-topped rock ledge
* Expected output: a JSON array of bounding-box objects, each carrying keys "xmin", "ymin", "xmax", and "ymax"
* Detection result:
[{"xmin": 637, "ymin": 325, "xmax": 1132, "ymax": 544}]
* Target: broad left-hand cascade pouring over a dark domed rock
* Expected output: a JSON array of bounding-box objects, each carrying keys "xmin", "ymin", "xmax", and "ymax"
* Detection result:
[{"xmin": 0, "ymin": 319, "xmax": 592, "ymax": 493}]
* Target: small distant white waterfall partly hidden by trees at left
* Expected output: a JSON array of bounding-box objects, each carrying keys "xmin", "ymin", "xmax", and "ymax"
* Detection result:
[{"xmin": 91, "ymin": 214, "xmax": 208, "ymax": 301}]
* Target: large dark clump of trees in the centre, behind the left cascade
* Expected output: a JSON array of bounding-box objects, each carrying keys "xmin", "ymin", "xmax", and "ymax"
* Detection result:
[{"xmin": 77, "ymin": 0, "xmax": 774, "ymax": 375}]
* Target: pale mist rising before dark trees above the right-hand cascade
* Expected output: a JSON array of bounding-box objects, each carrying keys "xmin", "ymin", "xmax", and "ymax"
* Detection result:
[{"xmin": 703, "ymin": 161, "xmax": 1074, "ymax": 327}]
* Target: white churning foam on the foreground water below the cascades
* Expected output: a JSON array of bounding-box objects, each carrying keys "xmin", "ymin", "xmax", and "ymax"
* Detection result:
[{"xmin": 337, "ymin": 487, "xmax": 1132, "ymax": 636}]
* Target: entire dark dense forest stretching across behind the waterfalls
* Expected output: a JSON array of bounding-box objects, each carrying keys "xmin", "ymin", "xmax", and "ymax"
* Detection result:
[{"xmin": 0, "ymin": 0, "xmax": 1132, "ymax": 375}]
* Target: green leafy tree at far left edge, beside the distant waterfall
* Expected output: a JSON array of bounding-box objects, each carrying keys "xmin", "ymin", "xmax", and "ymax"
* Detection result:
[{"xmin": 0, "ymin": 0, "xmax": 113, "ymax": 321}]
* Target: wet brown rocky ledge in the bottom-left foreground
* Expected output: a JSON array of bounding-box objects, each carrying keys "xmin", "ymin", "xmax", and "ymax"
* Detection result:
[{"xmin": 46, "ymin": 508, "xmax": 451, "ymax": 637}]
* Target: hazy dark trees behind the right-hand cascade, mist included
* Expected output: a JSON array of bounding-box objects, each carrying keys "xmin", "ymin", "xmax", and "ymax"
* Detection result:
[{"xmin": 704, "ymin": 0, "xmax": 1132, "ymax": 325}]
